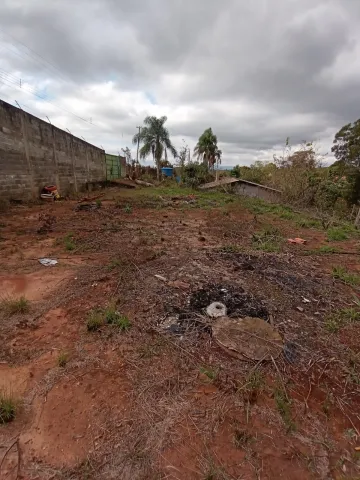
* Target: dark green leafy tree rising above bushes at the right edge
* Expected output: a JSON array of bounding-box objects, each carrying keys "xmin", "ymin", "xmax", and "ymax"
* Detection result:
[{"xmin": 331, "ymin": 119, "xmax": 360, "ymax": 167}]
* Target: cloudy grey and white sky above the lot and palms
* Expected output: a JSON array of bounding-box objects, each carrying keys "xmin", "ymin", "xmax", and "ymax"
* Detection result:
[{"xmin": 0, "ymin": 0, "xmax": 360, "ymax": 166}]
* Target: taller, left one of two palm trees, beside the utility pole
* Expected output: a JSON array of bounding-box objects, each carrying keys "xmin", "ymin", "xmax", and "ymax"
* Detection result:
[{"xmin": 133, "ymin": 116, "xmax": 177, "ymax": 180}]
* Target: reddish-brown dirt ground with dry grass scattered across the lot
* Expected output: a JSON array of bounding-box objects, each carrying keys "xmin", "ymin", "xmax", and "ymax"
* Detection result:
[{"xmin": 0, "ymin": 188, "xmax": 360, "ymax": 480}]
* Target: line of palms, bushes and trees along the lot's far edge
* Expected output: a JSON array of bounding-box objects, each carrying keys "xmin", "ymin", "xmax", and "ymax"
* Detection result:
[{"xmin": 131, "ymin": 112, "xmax": 360, "ymax": 208}]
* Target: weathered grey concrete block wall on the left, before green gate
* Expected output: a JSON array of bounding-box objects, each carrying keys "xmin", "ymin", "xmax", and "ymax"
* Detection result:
[{"xmin": 0, "ymin": 100, "xmax": 106, "ymax": 199}]
